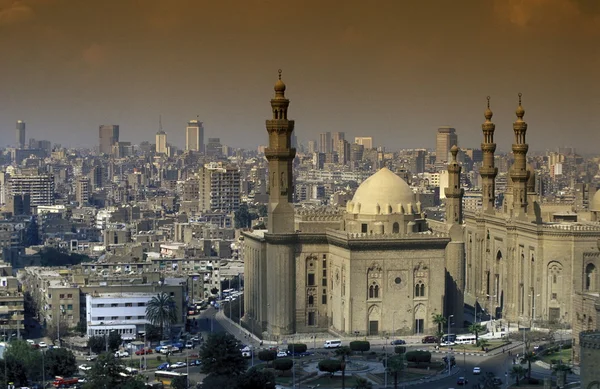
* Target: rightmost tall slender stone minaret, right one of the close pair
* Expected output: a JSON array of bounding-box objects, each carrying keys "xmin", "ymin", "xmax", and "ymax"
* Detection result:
[{"xmin": 510, "ymin": 93, "xmax": 530, "ymax": 217}]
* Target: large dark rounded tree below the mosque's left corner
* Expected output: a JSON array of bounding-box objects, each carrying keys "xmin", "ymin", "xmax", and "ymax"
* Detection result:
[{"xmin": 200, "ymin": 332, "xmax": 247, "ymax": 376}]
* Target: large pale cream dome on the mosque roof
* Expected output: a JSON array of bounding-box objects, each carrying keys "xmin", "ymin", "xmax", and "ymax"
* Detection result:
[{"xmin": 352, "ymin": 167, "xmax": 415, "ymax": 215}]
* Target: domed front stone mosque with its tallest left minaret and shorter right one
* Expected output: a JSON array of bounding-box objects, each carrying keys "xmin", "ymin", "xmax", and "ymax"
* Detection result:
[{"xmin": 244, "ymin": 76, "xmax": 464, "ymax": 339}]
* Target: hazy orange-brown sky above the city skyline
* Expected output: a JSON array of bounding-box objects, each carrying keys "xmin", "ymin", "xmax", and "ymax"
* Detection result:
[{"xmin": 0, "ymin": 0, "xmax": 600, "ymax": 152}]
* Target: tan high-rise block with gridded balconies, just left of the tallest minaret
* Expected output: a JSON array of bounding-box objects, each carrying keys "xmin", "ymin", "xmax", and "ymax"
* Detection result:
[{"xmin": 199, "ymin": 162, "xmax": 241, "ymax": 212}]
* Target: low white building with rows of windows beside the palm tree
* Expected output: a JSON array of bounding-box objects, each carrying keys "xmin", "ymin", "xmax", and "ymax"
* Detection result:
[{"xmin": 85, "ymin": 293, "xmax": 155, "ymax": 340}]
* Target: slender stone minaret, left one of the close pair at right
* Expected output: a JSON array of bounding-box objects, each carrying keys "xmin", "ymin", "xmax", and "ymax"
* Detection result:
[{"xmin": 479, "ymin": 96, "xmax": 498, "ymax": 213}]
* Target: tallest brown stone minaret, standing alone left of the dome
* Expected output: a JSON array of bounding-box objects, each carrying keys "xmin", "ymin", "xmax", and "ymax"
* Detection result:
[{"xmin": 265, "ymin": 69, "xmax": 296, "ymax": 234}]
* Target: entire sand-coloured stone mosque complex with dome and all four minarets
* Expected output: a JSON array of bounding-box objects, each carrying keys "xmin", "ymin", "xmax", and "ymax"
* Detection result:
[{"xmin": 243, "ymin": 73, "xmax": 600, "ymax": 360}]
